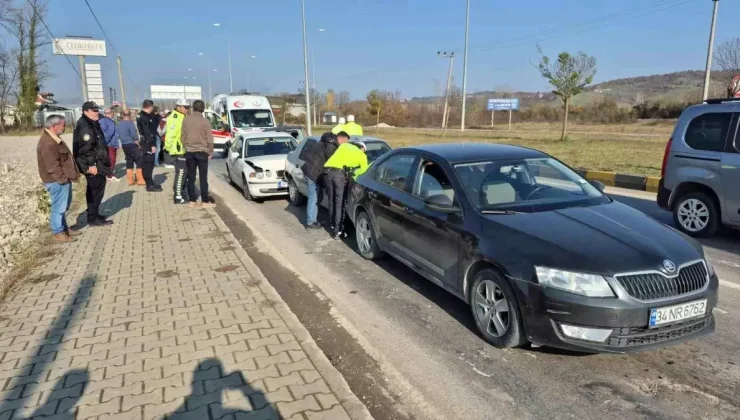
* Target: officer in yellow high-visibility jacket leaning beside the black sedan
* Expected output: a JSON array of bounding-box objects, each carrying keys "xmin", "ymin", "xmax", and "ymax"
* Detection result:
[{"xmin": 324, "ymin": 131, "xmax": 368, "ymax": 239}]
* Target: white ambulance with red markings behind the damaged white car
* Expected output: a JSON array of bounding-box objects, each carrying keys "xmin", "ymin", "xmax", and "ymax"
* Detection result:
[{"xmin": 205, "ymin": 94, "xmax": 275, "ymax": 154}]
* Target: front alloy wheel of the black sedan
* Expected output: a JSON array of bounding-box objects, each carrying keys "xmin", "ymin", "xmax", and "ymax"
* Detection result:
[{"xmin": 474, "ymin": 280, "xmax": 511, "ymax": 338}]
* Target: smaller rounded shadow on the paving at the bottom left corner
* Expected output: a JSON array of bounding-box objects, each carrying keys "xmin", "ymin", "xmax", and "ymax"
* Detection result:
[{"xmin": 29, "ymin": 369, "xmax": 90, "ymax": 420}]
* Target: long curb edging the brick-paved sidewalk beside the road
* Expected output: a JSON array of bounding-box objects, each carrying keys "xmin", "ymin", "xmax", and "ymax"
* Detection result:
[{"xmin": 206, "ymin": 184, "xmax": 372, "ymax": 420}]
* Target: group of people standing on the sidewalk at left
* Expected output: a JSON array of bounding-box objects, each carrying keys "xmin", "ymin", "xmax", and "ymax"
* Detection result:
[{"xmin": 36, "ymin": 100, "xmax": 214, "ymax": 242}]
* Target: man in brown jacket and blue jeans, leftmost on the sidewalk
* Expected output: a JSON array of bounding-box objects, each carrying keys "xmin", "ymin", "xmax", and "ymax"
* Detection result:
[{"xmin": 36, "ymin": 115, "xmax": 79, "ymax": 242}]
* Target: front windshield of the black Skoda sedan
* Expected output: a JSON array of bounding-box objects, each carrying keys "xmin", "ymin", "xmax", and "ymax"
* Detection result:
[{"xmin": 455, "ymin": 158, "xmax": 609, "ymax": 212}]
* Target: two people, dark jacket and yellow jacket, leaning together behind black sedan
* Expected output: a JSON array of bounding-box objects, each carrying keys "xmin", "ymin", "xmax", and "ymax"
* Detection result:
[{"xmin": 299, "ymin": 124, "xmax": 368, "ymax": 239}]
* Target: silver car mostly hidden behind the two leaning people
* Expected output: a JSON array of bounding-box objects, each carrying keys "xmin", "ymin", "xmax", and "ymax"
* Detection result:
[{"xmin": 285, "ymin": 136, "xmax": 391, "ymax": 207}]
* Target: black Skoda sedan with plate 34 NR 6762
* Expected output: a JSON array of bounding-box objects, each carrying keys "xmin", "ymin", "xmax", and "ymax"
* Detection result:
[{"xmin": 347, "ymin": 144, "xmax": 719, "ymax": 352}]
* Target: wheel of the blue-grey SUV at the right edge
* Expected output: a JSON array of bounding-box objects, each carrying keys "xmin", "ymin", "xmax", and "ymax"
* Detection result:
[{"xmin": 673, "ymin": 192, "xmax": 719, "ymax": 237}]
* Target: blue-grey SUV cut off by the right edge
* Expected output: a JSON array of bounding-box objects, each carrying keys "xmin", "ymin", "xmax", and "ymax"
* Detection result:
[{"xmin": 658, "ymin": 98, "xmax": 740, "ymax": 237}]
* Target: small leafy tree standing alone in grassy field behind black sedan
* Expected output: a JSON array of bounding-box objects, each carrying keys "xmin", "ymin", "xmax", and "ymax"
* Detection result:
[{"xmin": 537, "ymin": 46, "xmax": 596, "ymax": 140}]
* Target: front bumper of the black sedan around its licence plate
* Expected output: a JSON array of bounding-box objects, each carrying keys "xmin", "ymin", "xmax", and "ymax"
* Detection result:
[{"xmin": 519, "ymin": 275, "xmax": 719, "ymax": 353}]
